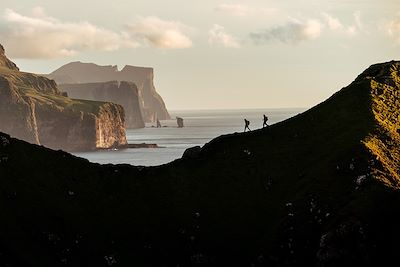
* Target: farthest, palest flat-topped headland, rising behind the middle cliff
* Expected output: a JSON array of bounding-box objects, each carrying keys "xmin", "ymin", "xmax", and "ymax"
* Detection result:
[{"xmin": 47, "ymin": 62, "xmax": 170, "ymax": 122}]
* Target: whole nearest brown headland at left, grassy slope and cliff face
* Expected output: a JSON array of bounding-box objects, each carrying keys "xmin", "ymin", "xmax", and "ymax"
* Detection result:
[{"xmin": 0, "ymin": 45, "xmax": 127, "ymax": 151}]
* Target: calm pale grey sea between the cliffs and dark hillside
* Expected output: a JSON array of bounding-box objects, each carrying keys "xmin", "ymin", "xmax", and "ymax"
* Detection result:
[{"xmin": 74, "ymin": 109, "xmax": 305, "ymax": 166}]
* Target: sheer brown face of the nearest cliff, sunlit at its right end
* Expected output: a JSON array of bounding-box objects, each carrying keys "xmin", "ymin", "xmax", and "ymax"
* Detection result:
[{"xmin": 32, "ymin": 100, "xmax": 127, "ymax": 151}]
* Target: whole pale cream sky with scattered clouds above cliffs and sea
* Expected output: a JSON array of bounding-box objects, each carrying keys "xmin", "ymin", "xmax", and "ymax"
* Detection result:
[{"xmin": 0, "ymin": 0, "xmax": 400, "ymax": 110}]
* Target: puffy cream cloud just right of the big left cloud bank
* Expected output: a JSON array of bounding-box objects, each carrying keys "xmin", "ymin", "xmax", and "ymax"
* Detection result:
[{"xmin": 127, "ymin": 17, "xmax": 192, "ymax": 49}]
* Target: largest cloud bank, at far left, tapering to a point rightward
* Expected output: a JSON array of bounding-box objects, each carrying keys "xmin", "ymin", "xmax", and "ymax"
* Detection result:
[{"xmin": 0, "ymin": 8, "xmax": 139, "ymax": 58}]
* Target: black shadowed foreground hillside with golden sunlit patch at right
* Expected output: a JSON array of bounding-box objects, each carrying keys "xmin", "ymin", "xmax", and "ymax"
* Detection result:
[{"xmin": 0, "ymin": 62, "xmax": 400, "ymax": 266}]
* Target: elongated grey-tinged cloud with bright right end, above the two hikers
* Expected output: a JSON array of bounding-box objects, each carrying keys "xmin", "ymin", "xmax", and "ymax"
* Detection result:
[{"xmin": 250, "ymin": 19, "xmax": 323, "ymax": 44}]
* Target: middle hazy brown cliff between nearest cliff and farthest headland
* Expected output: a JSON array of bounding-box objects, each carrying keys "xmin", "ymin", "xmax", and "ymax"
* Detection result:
[{"xmin": 59, "ymin": 81, "xmax": 145, "ymax": 128}]
